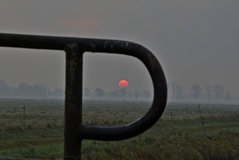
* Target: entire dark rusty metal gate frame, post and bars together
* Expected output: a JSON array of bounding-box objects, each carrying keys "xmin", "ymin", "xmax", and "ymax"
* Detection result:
[{"xmin": 0, "ymin": 33, "xmax": 167, "ymax": 160}]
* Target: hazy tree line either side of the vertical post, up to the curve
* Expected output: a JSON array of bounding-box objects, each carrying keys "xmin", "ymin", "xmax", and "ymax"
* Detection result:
[{"xmin": 0, "ymin": 80, "xmax": 152, "ymax": 100}]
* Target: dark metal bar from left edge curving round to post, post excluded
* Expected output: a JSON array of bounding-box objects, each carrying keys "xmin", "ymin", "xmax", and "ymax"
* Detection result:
[{"xmin": 0, "ymin": 33, "xmax": 167, "ymax": 152}]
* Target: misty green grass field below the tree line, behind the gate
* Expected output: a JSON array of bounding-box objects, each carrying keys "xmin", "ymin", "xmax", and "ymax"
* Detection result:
[{"xmin": 0, "ymin": 99, "xmax": 239, "ymax": 160}]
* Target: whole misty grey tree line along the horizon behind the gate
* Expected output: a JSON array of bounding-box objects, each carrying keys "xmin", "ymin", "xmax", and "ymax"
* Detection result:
[{"xmin": 3, "ymin": 80, "xmax": 232, "ymax": 102}]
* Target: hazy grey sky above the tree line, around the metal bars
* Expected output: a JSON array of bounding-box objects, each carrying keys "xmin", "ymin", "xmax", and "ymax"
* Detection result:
[{"xmin": 0, "ymin": 0, "xmax": 239, "ymax": 95}]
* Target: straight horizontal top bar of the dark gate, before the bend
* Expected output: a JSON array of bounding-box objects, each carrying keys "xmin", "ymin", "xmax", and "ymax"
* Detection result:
[{"xmin": 0, "ymin": 33, "xmax": 149, "ymax": 54}]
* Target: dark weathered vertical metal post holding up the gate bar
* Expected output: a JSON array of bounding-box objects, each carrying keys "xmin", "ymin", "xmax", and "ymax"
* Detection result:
[{"xmin": 64, "ymin": 43, "xmax": 83, "ymax": 160}]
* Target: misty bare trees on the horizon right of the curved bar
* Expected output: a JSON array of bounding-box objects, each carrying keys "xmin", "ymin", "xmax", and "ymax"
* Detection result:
[{"xmin": 168, "ymin": 83, "xmax": 231, "ymax": 102}]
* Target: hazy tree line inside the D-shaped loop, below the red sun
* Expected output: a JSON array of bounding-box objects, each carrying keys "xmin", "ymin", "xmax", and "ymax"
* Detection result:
[{"xmin": 83, "ymin": 87, "xmax": 152, "ymax": 100}]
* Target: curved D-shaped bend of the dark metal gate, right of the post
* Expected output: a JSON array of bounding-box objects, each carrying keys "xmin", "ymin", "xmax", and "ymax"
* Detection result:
[{"xmin": 79, "ymin": 41, "xmax": 167, "ymax": 140}]
